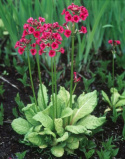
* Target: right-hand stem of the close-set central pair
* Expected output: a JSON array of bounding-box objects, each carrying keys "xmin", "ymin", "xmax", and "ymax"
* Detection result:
[{"xmin": 54, "ymin": 57, "xmax": 57, "ymax": 116}]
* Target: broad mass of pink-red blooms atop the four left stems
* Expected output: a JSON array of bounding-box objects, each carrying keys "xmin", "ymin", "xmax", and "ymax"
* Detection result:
[{"xmin": 15, "ymin": 17, "xmax": 64, "ymax": 57}]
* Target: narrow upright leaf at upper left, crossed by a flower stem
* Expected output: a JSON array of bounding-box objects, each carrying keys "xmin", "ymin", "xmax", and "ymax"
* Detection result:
[{"xmin": 38, "ymin": 84, "xmax": 48, "ymax": 110}]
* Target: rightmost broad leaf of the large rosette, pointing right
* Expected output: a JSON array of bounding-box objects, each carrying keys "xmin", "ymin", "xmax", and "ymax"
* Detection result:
[{"xmin": 77, "ymin": 115, "xmax": 106, "ymax": 129}]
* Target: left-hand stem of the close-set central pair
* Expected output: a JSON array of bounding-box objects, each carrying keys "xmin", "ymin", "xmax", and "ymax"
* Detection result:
[{"xmin": 51, "ymin": 58, "xmax": 56, "ymax": 119}]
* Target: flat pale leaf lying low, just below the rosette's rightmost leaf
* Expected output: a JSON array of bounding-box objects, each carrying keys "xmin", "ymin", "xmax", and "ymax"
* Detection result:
[{"xmin": 65, "ymin": 125, "xmax": 91, "ymax": 135}]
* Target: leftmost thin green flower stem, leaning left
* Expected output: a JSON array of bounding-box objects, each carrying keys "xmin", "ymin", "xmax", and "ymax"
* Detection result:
[{"xmin": 27, "ymin": 48, "xmax": 37, "ymax": 105}]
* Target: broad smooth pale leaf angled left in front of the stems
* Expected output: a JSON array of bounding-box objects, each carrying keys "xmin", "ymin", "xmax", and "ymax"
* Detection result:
[{"xmin": 33, "ymin": 112, "xmax": 54, "ymax": 130}]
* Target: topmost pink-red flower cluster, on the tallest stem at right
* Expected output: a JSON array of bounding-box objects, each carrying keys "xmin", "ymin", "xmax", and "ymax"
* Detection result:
[{"xmin": 61, "ymin": 3, "xmax": 89, "ymax": 37}]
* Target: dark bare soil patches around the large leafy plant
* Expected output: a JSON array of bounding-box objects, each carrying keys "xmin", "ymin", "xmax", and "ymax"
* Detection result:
[{"xmin": 0, "ymin": 48, "xmax": 125, "ymax": 159}]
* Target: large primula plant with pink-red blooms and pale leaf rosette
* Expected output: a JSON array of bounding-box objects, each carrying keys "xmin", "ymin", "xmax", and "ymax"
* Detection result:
[{"xmin": 12, "ymin": 4, "xmax": 105, "ymax": 157}]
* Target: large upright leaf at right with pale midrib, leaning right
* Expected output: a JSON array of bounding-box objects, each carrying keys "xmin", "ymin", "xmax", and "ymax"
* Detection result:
[{"xmin": 71, "ymin": 91, "xmax": 97, "ymax": 124}]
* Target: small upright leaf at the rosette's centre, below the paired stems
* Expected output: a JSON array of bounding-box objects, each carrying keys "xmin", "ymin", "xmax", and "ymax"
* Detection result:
[{"xmin": 54, "ymin": 118, "xmax": 64, "ymax": 136}]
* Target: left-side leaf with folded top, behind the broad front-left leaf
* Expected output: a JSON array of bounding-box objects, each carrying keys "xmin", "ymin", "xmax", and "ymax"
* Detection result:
[{"xmin": 22, "ymin": 104, "xmax": 40, "ymax": 126}]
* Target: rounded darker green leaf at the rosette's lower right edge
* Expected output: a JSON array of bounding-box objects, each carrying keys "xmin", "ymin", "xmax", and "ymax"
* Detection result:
[{"xmin": 66, "ymin": 136, "xmax": 79, "ymax": 150}]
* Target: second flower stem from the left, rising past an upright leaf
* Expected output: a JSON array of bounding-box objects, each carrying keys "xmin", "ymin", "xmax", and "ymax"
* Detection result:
[{"xmin": 36, "ymin": 50, "xmax": 46, "ymax": 109}]
